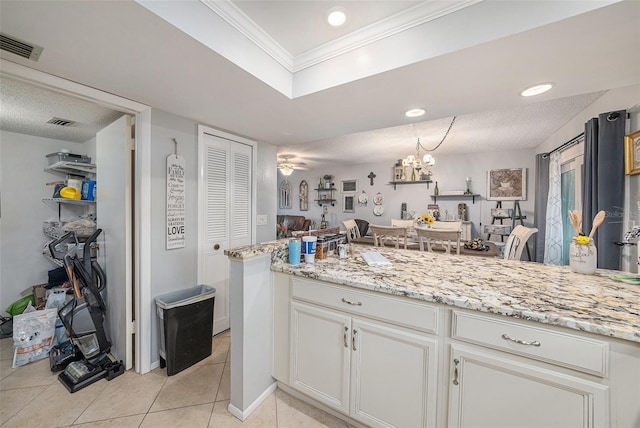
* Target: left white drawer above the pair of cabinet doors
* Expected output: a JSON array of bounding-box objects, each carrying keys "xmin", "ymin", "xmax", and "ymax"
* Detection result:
[{"xmin": 292, "ymin": 278, "xmax": 438, "ymax": 333}]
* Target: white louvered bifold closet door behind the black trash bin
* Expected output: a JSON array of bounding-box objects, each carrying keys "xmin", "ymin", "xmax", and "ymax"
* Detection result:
[{"xmin": 198, "ymin": 133, "xmax": 252, "ymax": 334}]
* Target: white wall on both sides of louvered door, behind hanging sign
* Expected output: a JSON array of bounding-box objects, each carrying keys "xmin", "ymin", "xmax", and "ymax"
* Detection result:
[{"xmin": 148, "ymin": 109, "xmax": 276, "ymax": 362}]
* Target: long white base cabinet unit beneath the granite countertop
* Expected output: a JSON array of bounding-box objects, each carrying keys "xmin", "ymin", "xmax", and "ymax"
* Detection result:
[{"xmin": 273, "ymin": 273, "xmax": 640, "ymax": 428}]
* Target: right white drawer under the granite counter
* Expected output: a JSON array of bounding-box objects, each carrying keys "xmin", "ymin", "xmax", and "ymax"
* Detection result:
[{"xmin": 451, "ymin": 311, "xmax": 609, "ymax": 376}]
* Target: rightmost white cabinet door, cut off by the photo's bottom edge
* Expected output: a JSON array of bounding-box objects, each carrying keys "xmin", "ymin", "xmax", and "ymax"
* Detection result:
[{"xmin": 448, "ymin": 345, "xmax": 609, "ymax": 428}]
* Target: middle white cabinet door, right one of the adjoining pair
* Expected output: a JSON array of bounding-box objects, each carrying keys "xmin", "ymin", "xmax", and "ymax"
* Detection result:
[{"xmin": 351, "ymin": 318, "xmax": 437, "ymax": 428}]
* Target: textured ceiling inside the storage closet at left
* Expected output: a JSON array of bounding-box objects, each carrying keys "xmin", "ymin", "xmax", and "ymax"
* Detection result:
[{"xmin": 0, "ymin": 77, "xmax": 122, "ymax": 143}]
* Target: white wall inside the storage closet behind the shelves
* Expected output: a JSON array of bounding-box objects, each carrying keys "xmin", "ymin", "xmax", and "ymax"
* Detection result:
[{"xmin": 0, "ymin": 131, "xmax": 89, "ymax": 313}]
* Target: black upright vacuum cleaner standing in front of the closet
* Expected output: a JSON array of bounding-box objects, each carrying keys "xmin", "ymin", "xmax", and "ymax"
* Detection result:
[{"xmin": 49, "ymin": 229, "xmax": 124, "ymax": 393}]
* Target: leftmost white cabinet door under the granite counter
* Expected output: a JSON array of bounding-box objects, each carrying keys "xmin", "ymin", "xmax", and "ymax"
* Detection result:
[{"xmin": 290, "ymin": 302, "xmax": 351, "ymax": 413}]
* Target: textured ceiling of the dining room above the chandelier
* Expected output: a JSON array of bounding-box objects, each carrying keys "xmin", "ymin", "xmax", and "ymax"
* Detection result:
[{"xmin": 278, "ymin": 91, "xmax": 604, "ymax": 165}]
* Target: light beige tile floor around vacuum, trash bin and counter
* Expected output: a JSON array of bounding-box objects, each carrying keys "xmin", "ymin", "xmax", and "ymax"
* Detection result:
[{"xmin": 0, "ymin": 332, "xmax": 348, "ymax": 428}]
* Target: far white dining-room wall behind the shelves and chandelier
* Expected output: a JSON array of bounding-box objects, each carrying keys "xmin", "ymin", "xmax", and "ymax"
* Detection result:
[{"xmin": 278, "ymin": 149, "xmax": 535, "ymax": 237}]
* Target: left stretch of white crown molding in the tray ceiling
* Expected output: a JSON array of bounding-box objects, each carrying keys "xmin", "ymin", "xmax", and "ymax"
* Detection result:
[{"xmin": 200, "ymin": 0, "xmax": 294, "ymax": 73}]
